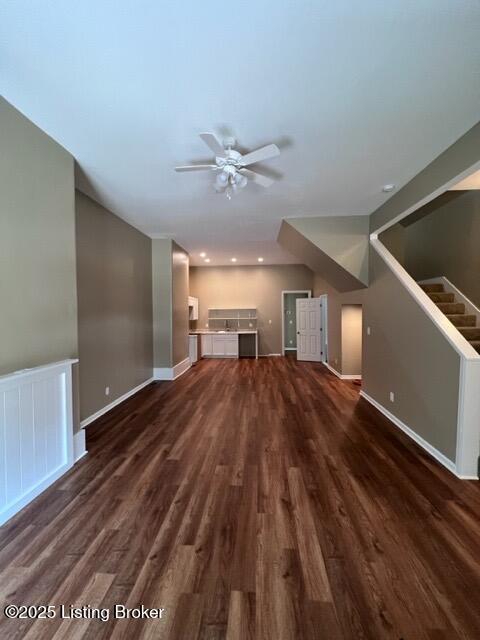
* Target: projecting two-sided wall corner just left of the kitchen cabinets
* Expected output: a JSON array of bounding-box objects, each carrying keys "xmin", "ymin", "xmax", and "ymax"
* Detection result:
[{"xmin": 152, "ymin": 238, "xmax": 189, "ymax": 368}]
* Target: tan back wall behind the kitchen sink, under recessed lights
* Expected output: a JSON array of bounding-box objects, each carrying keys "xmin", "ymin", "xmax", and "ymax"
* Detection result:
[{"xmin": 190, "ymin": 265, "xmax": 313, "ymax": 355}]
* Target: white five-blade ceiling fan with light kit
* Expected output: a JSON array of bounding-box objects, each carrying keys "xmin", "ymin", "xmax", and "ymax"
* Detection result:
[{"xmin": 175, "ymin": 133, "xmax": 280, "ymax": 200}]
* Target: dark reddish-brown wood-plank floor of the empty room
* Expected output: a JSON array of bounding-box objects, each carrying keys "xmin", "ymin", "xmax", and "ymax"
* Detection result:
[{"xmin": 0, "ymin": 358, "xmax": 480, "ymax": 640}]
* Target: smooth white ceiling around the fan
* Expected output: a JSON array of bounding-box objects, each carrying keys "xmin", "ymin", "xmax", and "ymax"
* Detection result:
[{"xmin": 0, "ymin": 0, "xmax": 480, "ymax": 265}]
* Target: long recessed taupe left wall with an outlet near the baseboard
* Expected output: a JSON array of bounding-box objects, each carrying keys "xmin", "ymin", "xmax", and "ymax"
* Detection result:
[{"xmin": 75, "ymin": 191, "xmax": 153, "ymax": 420}]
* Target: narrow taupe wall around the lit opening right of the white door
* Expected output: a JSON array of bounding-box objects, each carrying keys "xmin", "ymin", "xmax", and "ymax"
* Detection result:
[{"xmin": 314, "ymin": 273, "xmax": 366, "ymax": 375}]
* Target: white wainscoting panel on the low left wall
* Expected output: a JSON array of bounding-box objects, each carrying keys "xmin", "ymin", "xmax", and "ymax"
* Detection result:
[{"xmin": 0, "ymin": 360, "xmax": 76, "ymax": 525}]
